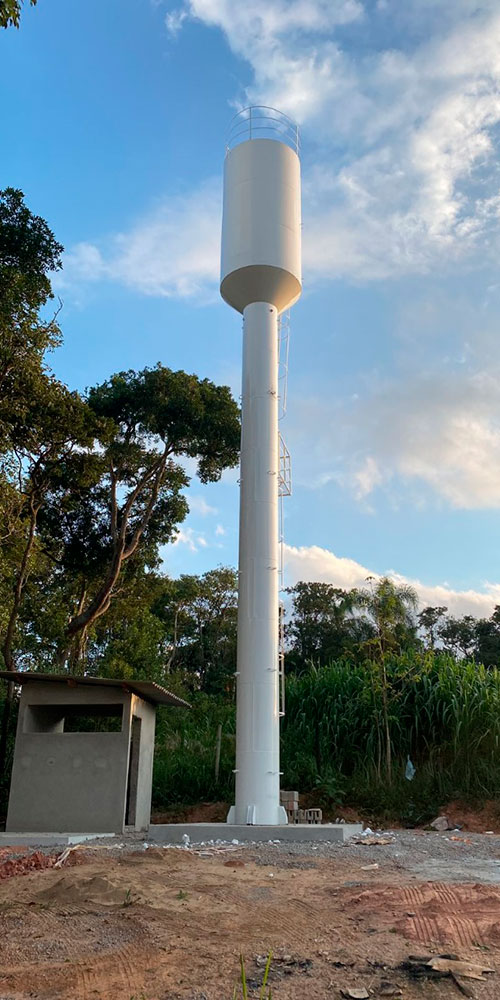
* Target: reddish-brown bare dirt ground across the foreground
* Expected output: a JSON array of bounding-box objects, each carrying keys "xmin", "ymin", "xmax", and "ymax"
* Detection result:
[{"xmin": 0, "ymin": 833, "xmax": 500, "ymax": 1000}]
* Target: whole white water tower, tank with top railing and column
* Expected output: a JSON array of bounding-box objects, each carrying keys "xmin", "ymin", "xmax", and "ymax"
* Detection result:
[{"xmin": 220, "ymin": 108, "xmax": 302, "ymax": 825}]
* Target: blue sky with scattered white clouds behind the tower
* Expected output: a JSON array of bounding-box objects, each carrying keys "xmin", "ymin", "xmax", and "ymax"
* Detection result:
[{"xmin": 0, "ymin": 0, "xmax": 500, "ymax": 614}]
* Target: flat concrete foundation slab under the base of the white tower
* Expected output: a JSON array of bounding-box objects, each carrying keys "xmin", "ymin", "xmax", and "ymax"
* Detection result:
[{"xmin": 147, "ymin": 823, "xmax": 363, "ymax": 844}]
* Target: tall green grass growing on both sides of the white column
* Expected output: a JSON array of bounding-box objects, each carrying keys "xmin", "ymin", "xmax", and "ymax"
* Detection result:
[{"xmin": 153, "ymin": 652, "xmax": 500, "ymax": 822}]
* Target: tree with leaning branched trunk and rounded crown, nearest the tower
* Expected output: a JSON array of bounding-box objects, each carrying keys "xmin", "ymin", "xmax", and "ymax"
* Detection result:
[{"xmin": 43, "ymin": 365, "xmax": 240, "ymax": 664}]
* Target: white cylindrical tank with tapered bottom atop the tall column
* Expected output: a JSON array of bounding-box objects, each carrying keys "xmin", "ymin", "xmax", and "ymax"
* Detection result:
[{"xmin": 220, "ymin": 127, "xmax": 302, "ymax": 313}]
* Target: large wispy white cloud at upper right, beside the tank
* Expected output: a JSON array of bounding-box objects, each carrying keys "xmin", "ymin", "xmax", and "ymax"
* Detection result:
[{"xmin": 166, "ymin": 0, "xmax": 500, "ymax": 280}]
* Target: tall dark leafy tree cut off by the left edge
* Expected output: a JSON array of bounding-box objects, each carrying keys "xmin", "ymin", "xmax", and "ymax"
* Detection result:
[{"xmin": 0, "ymin": 189, "xmax": 63, "ymax": 767}]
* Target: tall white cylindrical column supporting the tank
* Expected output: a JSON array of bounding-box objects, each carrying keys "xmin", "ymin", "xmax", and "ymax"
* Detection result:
[{"xmin": 228, "ymin": 302, "xmax": 287, "ymax": 824}]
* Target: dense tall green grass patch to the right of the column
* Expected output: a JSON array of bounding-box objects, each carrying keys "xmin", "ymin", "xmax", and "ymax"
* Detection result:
[{"xmin": 282, "ymin": 652, "xmax": 500, "ymax": 819}]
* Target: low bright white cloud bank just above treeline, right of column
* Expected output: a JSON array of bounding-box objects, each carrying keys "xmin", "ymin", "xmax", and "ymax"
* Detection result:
[{"xmin": 285, "ymin": 545, "xmax": 500, "ymax": 618}]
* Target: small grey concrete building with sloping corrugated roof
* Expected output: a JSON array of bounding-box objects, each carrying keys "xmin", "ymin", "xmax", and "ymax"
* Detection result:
[{"xmin": 0, "ymin": 671, "xmax": 189, "ymax": 834}]
